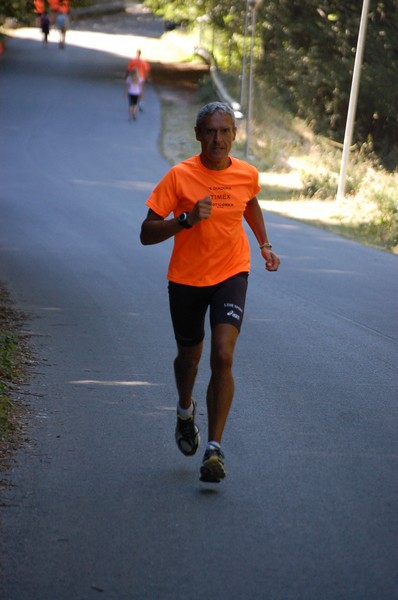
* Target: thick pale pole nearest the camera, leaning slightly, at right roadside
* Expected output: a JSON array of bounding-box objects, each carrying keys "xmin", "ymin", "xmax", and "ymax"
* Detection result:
[{"xmin": 336, "ymin": 0, "xmax": 370, "ymax": 201}]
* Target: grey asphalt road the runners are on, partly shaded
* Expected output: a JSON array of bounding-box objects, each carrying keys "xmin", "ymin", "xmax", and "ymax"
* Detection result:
[{"xmin": 0, "ymin": 18, "xmax": 398, "ymax": 600}]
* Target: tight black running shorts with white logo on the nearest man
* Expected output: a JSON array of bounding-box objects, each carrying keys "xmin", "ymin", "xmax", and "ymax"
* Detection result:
[{"xmin": 169, "ymin": 273, "xmax": 249, "ymax": 346}]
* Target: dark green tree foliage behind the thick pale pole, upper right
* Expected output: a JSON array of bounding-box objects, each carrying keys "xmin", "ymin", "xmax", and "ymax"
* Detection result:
[{"xmin": 261, "ymin": 0, "xmax": 398, "ymax": 168}]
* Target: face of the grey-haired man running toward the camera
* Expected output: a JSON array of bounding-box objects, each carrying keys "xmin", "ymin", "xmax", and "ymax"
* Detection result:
[{"xmin": 195, "ymin": 112, "xmax": 236, "ymax": 170}]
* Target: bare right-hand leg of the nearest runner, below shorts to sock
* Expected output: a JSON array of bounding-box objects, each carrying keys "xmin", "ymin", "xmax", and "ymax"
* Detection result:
[{"xmin": 207, "ymin": 324, "xmax": 239, "ymax": 443}]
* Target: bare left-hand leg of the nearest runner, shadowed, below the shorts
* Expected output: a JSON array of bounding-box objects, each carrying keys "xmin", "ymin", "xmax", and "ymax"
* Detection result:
[{"xmin": 174, "ymin": 342, "xmax": 203, "ymax": 409}]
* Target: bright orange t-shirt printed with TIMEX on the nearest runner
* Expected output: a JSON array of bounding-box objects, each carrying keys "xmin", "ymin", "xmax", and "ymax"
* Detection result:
[{"xmin": 146, "ymin": 155, "xmax": 260, "ymax": 286}]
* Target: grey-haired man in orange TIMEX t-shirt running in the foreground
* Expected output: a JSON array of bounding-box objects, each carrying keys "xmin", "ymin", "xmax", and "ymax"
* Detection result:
[{"xmin": 141, "ymin": 102, "xmax": 280, "ymax": 483}]
